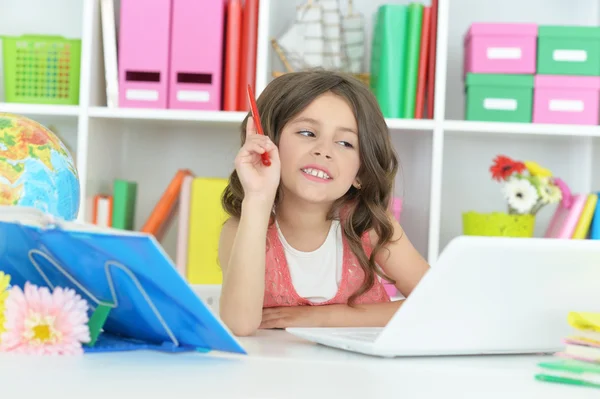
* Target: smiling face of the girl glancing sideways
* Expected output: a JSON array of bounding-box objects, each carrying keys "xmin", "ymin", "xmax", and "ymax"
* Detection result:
[{"xmin": 279, "ymin": 93, "xmax": 360, "ymax": 204}]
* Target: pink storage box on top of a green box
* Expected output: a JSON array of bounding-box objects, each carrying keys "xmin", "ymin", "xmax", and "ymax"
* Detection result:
[{"xmin": 464, "ymin": 23, "xmax": 538, "ymax": 74}]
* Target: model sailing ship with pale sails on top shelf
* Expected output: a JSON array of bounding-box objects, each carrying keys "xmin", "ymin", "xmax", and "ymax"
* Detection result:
[{"xmin": 271, "ymin": 0, "xmax": 368, "ymax": 82}]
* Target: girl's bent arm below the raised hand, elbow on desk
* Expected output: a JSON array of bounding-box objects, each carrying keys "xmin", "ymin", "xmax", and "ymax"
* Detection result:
[{"xmin": 219, "ymin": 198, "xmax": 272, "ymax": 336}]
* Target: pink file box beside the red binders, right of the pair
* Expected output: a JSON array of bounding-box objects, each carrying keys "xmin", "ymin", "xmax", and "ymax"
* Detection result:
[{"xmin": 169, "ymin": 0, "xmax": 227, "ymax": 111}]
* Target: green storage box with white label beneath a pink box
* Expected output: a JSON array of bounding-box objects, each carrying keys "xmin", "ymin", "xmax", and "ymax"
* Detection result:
[{"xmin": 465, "ymin": 73, "xmax": 534, "ymax": 123}]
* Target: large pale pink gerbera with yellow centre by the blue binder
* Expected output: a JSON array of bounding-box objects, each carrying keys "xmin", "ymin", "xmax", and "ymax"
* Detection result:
[{"xmin": 0, "ymin": 283, "xmax": 90, "ymax": 355}]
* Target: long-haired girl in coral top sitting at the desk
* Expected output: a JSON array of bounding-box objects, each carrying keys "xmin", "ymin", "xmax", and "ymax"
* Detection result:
[{"xmin": 219, "ymin": 71, "xmax": 429, "ymax": 336}]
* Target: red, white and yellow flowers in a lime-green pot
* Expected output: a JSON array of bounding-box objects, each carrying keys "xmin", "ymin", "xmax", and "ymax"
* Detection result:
[{"xmin": 463, "ymin": 155, "xmax": 571, "ymax": 237}]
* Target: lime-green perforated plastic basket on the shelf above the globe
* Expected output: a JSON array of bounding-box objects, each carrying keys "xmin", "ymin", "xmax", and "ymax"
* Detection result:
[{"xmin": 2, "ymin": 35, "xmax": 81, "ymax": 105}]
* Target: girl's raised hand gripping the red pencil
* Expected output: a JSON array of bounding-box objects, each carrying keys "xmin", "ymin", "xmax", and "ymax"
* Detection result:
[{"xmin": 235, "ymin": 117, "xmax": 281, "ymax": 200}]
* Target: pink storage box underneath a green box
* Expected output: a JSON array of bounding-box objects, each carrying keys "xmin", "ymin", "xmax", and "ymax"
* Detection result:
[{"xmin": 533, "ymin": 75, "xmax": 600, "ymax": 125}]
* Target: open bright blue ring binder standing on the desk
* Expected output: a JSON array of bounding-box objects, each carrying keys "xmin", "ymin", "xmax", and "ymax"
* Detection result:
[{"xmin": 0, "ymin": 207, "xmax": 246, "ymax": 354}]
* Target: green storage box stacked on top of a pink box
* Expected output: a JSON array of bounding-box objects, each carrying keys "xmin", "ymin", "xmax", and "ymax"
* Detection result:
[{"xmin": 537, "ymin": 26, "xmax": 600, "ymax": 76}]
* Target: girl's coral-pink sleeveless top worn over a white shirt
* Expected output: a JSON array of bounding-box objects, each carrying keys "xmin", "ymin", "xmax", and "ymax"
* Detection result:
[{"xmin": 263, "ymin": 224, "xmax": 390, "ymax": 308}]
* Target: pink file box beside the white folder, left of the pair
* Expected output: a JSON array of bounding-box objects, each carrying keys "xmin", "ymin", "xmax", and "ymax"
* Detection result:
[{"xmin": 119, "ymin": 0, "xmax": 171, "ymax": 108}]
